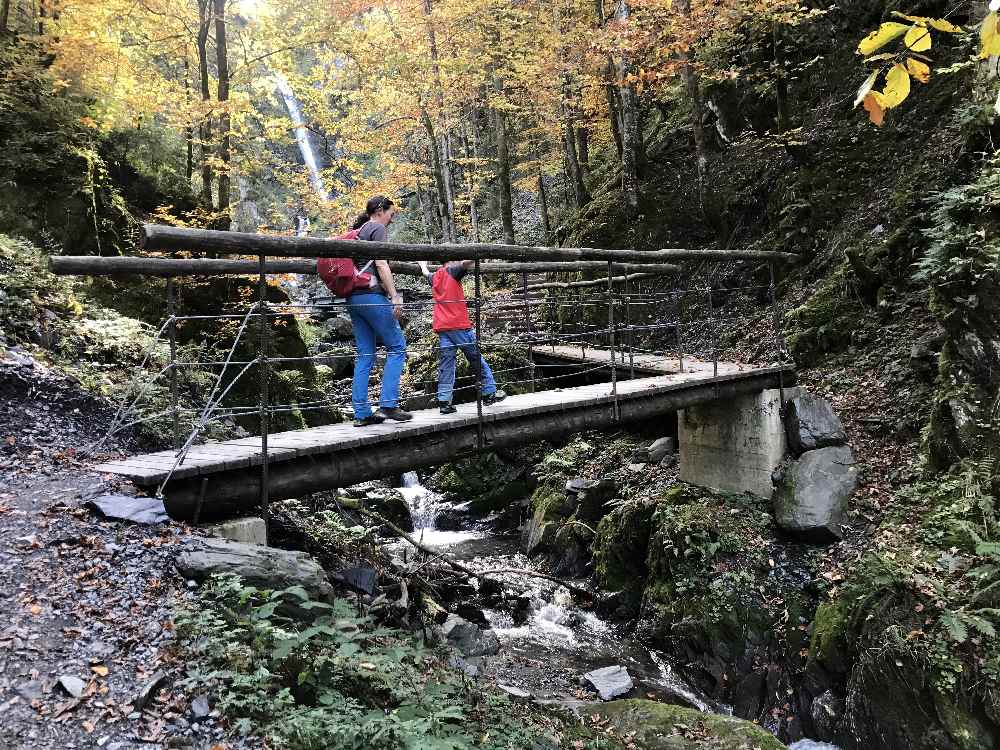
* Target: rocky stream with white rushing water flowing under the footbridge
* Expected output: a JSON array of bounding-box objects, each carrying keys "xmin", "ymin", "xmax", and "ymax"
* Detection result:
[{"xmin": 397, "ymin": 472, "xmax": 837, "ymax": 750}]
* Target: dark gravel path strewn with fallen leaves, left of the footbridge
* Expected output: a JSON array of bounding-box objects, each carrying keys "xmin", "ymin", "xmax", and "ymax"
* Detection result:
[{"xmin": 0, "ymin": 350, "xmax": 252, "ymax": 750}]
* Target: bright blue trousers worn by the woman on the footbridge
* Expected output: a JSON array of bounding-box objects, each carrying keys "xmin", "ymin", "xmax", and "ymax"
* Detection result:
[{"xmin": 347, "ymin": 292, "xmax": 406, "ymax": 419}]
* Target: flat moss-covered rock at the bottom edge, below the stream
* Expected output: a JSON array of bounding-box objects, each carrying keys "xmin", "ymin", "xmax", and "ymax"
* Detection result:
[{"xmin": 587, "ymin": 699, "xmax": 785, "ymax": 750}]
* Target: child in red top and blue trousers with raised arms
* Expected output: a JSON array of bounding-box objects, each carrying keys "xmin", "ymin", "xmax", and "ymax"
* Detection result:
[{"xmin": 420, "ymin": 260, "xmax": 507, "ymax": 414}]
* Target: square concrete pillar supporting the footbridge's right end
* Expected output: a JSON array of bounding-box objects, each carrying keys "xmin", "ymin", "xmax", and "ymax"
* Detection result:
[{"xmin": 677, "ymin": 388, "xmax": 799, "ymax": 499}]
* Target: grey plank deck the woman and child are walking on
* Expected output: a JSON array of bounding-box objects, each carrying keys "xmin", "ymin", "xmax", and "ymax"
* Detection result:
[{"xmin": 95, "ymin": 362, "xmax": 794, "ymax": 486}]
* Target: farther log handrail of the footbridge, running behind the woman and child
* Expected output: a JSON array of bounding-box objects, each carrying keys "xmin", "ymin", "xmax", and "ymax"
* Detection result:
[{"xmin": 49, "ymin": 256, "xmax": 681, "ymax": 278}]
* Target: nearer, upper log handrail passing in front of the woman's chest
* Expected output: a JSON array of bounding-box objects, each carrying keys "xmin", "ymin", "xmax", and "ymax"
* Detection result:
[{"xmin": 140, "ymin": 224, "xmax": 799, "ymax": 263}]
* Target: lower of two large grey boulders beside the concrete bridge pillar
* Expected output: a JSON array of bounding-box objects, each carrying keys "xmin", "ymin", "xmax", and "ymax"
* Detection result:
[{"xmin": 774, "ymin": 445, "xmax": 858, "ymax": 542}]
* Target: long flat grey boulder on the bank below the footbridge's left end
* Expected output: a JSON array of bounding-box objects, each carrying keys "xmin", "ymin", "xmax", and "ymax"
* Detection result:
[{"xmin": 176, "ymin": 539, "xmax": 333, "ymax": 601}]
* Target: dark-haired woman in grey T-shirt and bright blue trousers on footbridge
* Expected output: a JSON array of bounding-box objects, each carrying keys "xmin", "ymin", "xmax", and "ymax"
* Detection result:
[{"xmin": 347, "ymin": 195, "xmax": 413, "ymax": 427}]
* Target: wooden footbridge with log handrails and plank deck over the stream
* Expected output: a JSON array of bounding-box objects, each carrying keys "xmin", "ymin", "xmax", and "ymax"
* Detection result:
[{"xmin": 58, "ymin": 226, "xmax": 795, "ymax": 520}]
